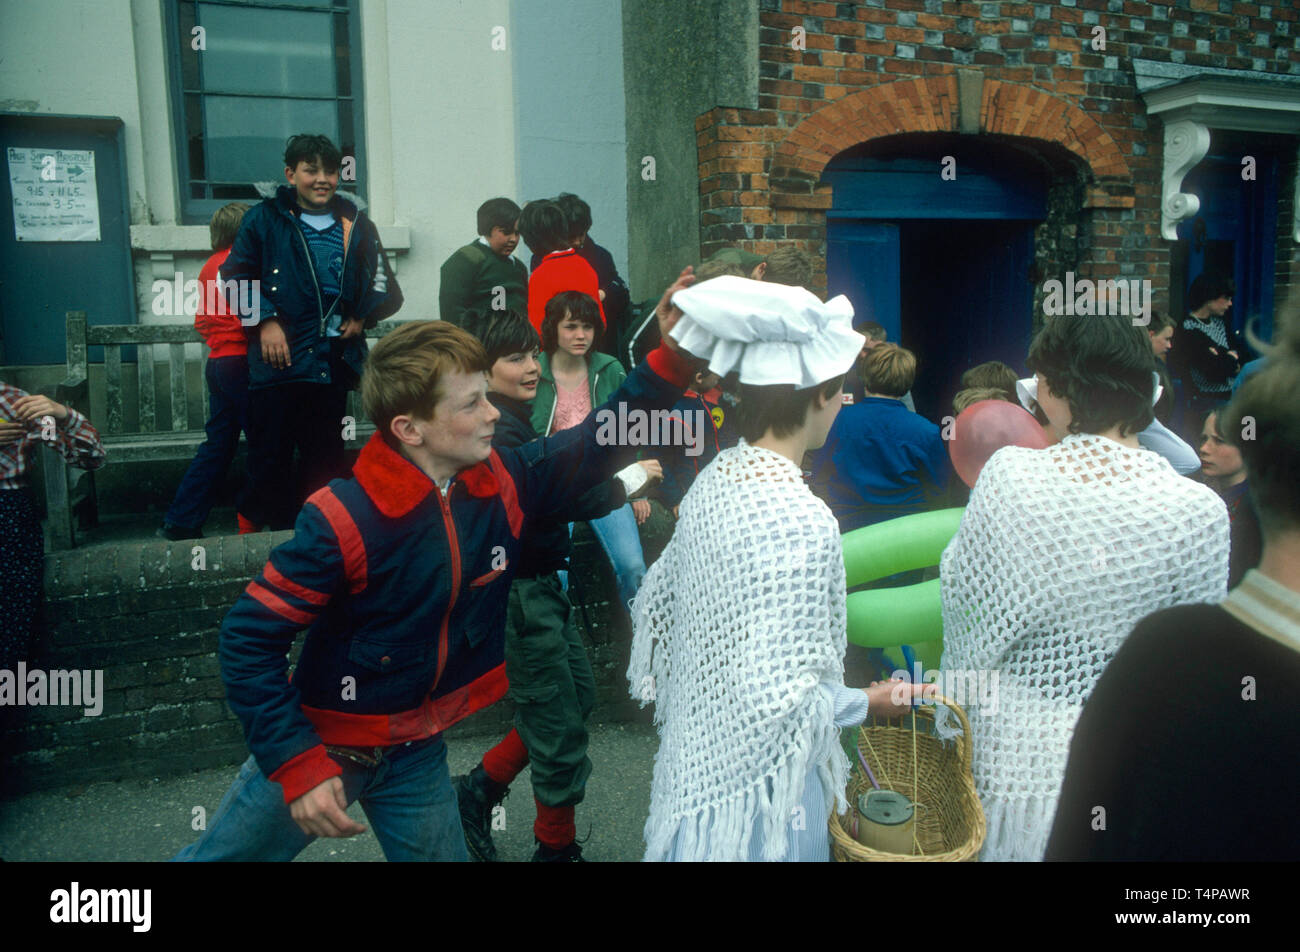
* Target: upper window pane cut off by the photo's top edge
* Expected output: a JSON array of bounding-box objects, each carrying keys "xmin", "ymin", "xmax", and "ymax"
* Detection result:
[{"xmin": 199, "ymin": 4, "xmax": 335, "ymax": 96}]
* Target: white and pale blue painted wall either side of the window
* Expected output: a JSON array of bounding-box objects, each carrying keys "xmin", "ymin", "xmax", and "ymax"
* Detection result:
[{"xmin": 0, "ymin": 0, "xmax": 627, "ymax": 356}]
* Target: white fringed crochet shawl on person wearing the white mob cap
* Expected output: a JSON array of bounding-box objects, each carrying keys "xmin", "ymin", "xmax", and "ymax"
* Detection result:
[{"xmin": 628, "ymin": 440, "xmax": 849, "ymax": 861}]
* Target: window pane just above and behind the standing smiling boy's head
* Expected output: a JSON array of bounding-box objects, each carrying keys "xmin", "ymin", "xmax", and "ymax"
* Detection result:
[{"xmin": 204, "ymin": 96, "xmax": 339, "ymax": 182}]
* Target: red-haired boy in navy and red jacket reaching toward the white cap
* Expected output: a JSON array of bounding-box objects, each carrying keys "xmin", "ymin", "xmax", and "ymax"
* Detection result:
[{"xmin": 177, "ymin": 269, "xmax": 694, "ymax": 860}]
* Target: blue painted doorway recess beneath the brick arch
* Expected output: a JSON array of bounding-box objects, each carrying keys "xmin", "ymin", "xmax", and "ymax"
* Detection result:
[{"xmin": 822, "ymin": 143, "xmax": 1047, "ymax": 421}]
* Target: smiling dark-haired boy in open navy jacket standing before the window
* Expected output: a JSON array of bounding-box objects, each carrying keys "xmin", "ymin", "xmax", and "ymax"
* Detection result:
[{"xmin": 218, "ymin": 135, "xmax": 402, "ymax": 532}]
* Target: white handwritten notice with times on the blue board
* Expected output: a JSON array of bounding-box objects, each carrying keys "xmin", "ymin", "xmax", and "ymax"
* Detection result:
[{"xmin": 7, "ymin": 148, "xmax": 99, "ymax": 242}]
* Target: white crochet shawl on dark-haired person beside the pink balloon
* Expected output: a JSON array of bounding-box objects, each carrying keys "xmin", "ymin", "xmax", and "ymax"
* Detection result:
[{"xmin": 940, "ymin": 434, "xmax": 1229, "ymax": 861}]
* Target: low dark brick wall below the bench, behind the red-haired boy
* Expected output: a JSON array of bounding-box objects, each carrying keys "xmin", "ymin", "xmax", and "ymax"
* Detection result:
[{"xmin": 0, "ymin": 525, "xmax": 650, "ymax": 796}]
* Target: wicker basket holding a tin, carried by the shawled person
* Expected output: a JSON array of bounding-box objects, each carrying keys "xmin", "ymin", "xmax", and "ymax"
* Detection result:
[{"xmin": 831, "ymin": 697, "xmax": 984, "ymax": 862}]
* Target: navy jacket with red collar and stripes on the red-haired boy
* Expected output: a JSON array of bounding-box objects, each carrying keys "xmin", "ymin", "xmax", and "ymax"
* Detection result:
[{"xmin": 220, "ymin": 347, "xmax": 694, "ymax": 802}]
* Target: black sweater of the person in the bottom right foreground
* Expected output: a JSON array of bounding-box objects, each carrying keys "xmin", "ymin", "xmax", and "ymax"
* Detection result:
[{"xmin": 1045, "ymin": 605, "xmax": 1300, "ymax": 861}]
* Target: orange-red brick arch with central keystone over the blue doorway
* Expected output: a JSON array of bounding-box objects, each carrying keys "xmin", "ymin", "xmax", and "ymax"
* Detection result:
[{"xmin": 771, "ymin": 74, "xmax": 1131, "ymax": 197}]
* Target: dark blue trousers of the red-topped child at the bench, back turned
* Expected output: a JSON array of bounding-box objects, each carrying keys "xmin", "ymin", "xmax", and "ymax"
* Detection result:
[{"xmin": 164, "ymin": 356, "xmax": 248, "ymax": 529}]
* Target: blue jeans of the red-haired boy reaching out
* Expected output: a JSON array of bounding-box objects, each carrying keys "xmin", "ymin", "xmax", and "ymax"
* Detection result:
[{"xmin": 174, "ymin": 735, "xmax": 469, "ymax": 862}]
